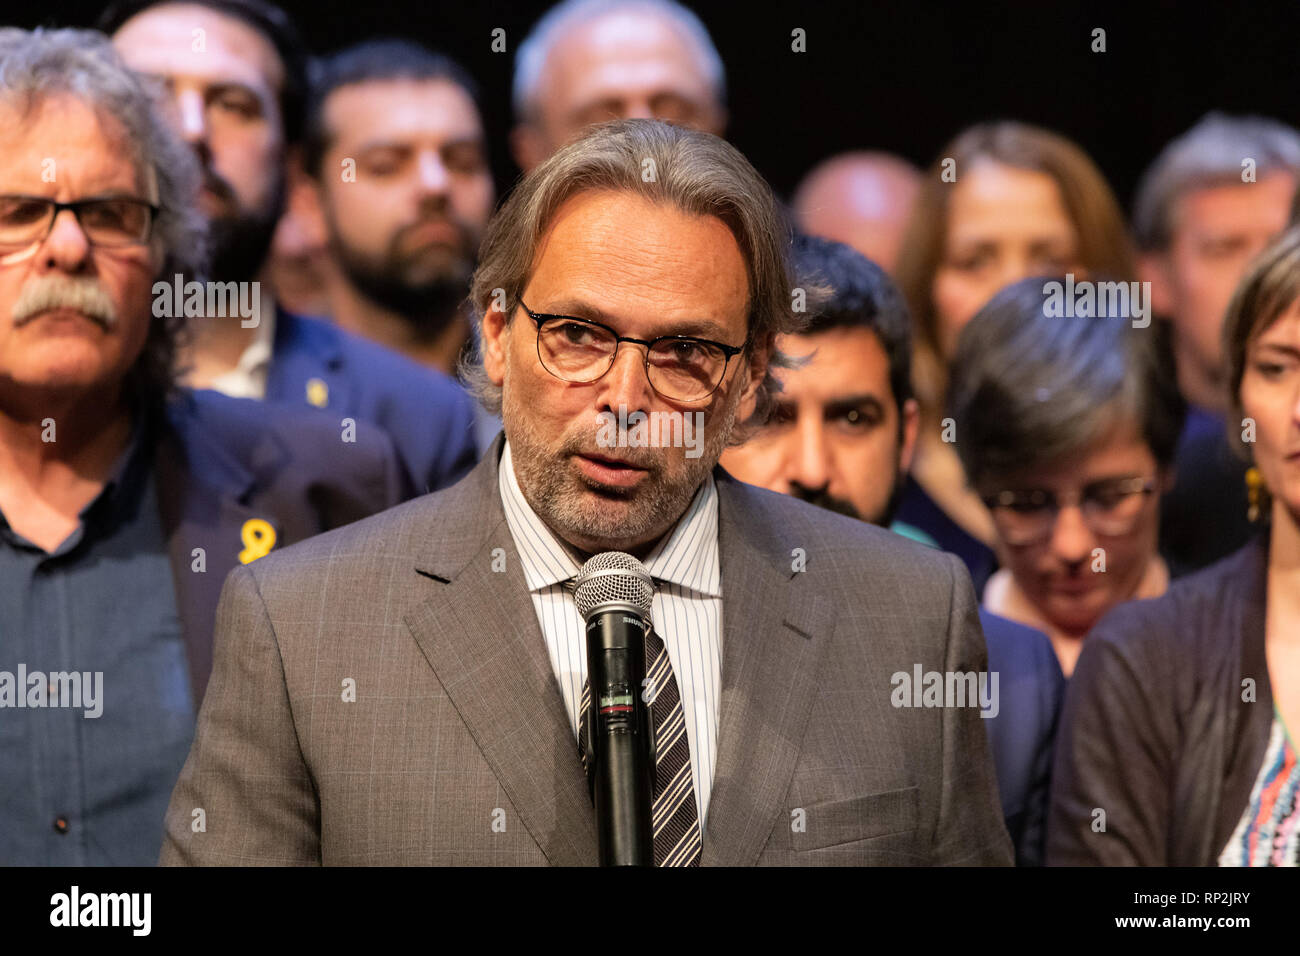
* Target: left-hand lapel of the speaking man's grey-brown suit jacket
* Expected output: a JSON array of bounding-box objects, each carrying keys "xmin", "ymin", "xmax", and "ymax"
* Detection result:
[{"xmin": 406, "ymin": 437, "xmax": 597, "ymax": 866}]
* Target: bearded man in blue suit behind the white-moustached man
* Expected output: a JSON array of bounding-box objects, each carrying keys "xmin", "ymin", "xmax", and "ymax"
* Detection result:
[{"xmin": 100, "ymin": 0, "xmax": 477, "ymax": 493}]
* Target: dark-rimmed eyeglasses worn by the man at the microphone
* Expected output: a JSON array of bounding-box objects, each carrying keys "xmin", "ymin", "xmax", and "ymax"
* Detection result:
[{"xmin": 519, "ymin": 299, "xmax": 749, "ymax": 402}]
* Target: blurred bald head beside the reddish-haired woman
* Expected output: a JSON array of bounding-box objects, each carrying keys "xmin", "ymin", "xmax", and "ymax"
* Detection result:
[{"xmin": 794, "ymin": 152, "xmax": 920, "ymax": 272}]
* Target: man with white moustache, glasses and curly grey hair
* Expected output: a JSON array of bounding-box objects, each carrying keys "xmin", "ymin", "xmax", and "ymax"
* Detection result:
[{"xmin": 0, "ymin": 30, "xmax": 408, "ymax": 865}]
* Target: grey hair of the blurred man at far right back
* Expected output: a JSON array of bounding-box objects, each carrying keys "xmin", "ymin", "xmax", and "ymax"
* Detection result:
[{"xmin": 1134, "ymin": 112, "xmax": 1300, "ymax": 251}]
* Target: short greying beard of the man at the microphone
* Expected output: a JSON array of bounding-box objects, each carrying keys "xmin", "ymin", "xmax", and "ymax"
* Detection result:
[{"xmin": 502, "ymin": 372, "xmax": 741, "ymax": 549}]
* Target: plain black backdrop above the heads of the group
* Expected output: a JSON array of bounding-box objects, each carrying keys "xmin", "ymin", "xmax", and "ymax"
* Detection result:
[{"xmin": 17, "ymin": 0, "xmax": 1300, "ymax": 206}]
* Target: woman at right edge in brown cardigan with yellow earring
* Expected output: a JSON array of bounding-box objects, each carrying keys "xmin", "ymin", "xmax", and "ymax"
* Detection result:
[{"xmin": 1048, "ymin": 230, "xmax": 1300, "ymax": 866}]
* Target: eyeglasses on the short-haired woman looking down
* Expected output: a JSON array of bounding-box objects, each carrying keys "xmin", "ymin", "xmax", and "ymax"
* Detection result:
[{"xmin": 983, "ymin": 475, "xmax": 1157, "ymax": 546}]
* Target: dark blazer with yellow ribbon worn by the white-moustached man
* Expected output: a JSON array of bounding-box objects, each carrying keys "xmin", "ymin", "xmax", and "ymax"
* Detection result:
[{"xmin": 153, "ymin": 390, "xmax": 407, "ymax": 708}]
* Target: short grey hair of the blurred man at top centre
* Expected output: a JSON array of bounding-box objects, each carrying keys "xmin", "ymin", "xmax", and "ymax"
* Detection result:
[{"xmin": 511, "ymin": 0, "xmax": 727, "ymax": 118}]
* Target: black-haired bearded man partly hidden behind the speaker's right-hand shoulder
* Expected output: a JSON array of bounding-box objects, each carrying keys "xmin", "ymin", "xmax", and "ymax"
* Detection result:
[{"xmin": 722, "ymin": 235, "xmax": 1065, "ymax": 866}]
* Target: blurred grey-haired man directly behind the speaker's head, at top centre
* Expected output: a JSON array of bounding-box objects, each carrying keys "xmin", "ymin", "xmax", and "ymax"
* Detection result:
[{"xmin": 510, "ymin": 0, "xmax": 727, "ymax": 173}]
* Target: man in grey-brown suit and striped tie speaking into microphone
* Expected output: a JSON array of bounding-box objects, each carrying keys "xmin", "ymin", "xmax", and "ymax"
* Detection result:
[{"xmin": 163, "ymin": 120, "xmax": 1011, "ymax": 866}]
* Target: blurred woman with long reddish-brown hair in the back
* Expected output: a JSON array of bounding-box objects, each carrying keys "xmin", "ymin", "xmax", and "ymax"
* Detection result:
[{"xmin": 896, "ymin": 121, "xmax": 1136, "ymax": 594}]
